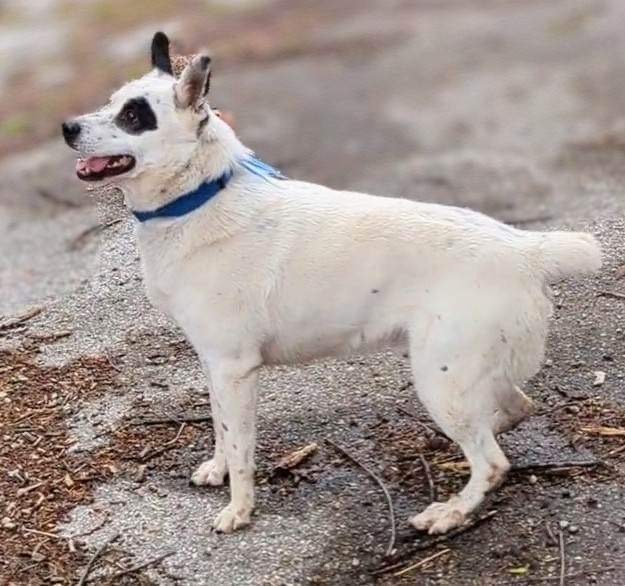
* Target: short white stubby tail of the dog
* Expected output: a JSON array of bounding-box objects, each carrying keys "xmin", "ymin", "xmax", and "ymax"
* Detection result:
[{"xmin": 538, "ymin": 232, "xmax": 602, "ymax": 283}]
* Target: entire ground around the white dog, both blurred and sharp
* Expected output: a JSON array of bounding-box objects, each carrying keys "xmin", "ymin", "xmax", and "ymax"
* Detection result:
[{"xmin": 0, "ymin": 0, "xmax": 625, "ymax": 586}]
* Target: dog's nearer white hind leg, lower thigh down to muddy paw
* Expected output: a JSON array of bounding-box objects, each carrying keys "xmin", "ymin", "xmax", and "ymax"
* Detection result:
[{"xmin": 410, "ymin": 340, "xmax": 510, "ymax": 533}]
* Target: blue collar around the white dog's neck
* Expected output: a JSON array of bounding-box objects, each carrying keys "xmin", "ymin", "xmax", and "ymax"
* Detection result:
[{"xmin": 132, "ymin": 155, "xmax": 286, "ymax": 222}]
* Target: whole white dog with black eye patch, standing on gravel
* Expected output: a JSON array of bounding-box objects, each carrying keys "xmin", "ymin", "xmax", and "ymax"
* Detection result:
[{"xmin": 63, "ymin": 33, "xmax": 601, "ymax": 533}]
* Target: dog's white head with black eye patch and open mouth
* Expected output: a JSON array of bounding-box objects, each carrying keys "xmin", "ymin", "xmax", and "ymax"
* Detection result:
[{"xmin": 63, "ymin": 32, "xmax": 216, "ymax": 186}]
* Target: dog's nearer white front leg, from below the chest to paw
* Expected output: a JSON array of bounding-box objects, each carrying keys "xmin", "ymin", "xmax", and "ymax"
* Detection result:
[{"xmin": 211, "ymin": 360, "xmax": 259, "ymax": 533}]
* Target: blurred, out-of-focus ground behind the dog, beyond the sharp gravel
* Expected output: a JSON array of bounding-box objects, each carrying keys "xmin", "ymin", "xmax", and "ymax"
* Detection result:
[{"xmin": 0, "ymin": 0, "xmax": 625, "ymax": 311}]
